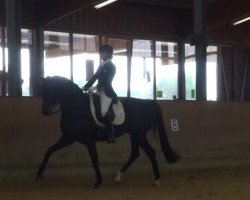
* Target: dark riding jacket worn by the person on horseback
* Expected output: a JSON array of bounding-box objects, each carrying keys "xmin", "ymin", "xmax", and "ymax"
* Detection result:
[{"xmin": 83, "ymin": 59, "xmax": 117, "ymax": 99}]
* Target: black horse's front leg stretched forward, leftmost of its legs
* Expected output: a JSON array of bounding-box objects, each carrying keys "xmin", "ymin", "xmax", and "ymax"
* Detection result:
[{"xmin": 36, "ymin": 136, "xmax": 74, "ymax": 180}]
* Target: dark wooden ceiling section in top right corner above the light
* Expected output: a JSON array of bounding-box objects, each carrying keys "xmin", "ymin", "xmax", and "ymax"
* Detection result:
[{"xmin": 207, "ymin": 0, "xmax": 250, "ymax": 30}]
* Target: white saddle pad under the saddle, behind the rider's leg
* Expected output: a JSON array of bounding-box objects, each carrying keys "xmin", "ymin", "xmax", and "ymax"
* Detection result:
[{"xmin": 89, "ymin": 94, "xmax": 125, "ymax": 127}]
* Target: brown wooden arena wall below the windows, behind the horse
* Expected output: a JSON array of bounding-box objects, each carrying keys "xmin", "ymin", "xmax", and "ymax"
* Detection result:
[{"xmin": 0, "ymin": 97, "xmax": 250, "ymax": 173}]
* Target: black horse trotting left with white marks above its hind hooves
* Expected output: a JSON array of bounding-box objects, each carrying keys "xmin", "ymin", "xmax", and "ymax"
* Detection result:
[{"xmin": 36, "ymin": 76, "xmax": 180, "ymax": 188}]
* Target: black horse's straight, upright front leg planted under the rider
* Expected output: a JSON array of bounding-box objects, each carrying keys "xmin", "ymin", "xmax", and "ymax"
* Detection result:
[{"xmin": 86, "ymin": 142, "xmax": 102, "ymax": 189}]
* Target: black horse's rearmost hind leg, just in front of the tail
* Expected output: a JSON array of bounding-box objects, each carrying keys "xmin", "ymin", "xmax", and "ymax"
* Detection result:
[{"xmin": 140, "ymin": 138, "xmax": 160, "ymax": 186}]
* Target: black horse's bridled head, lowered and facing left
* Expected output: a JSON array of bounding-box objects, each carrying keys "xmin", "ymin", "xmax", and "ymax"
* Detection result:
[{"xmin": 41, "ymin": 77, "xmax": 60, "ymax": 116}]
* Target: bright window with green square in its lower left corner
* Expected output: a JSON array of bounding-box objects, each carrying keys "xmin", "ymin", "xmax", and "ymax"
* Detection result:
[{"xmin": 156, "ymin": 41, "xmax": 178, "ymax": 99}]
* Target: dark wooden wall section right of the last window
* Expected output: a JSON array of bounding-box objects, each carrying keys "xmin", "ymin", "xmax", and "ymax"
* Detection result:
[{"xmin": 218, "ymin": 46, "xmax": 250, "ymax": 101}]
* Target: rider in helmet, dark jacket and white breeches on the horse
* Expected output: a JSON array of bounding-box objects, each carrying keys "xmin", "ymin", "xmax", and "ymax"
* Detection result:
[{"xmin": 82, "ymin": 44, "xmax": 117, "ymax": 143}]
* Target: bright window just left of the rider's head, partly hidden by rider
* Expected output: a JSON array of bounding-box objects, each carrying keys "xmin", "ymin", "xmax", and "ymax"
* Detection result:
[{"xmin": 73, "ymin": 34, "xmax": 100, "ymax": 87}]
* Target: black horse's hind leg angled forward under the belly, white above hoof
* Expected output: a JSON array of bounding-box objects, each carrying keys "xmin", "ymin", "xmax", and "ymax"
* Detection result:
[{"xmin": 115, "ymin": 137, "xmax": 140, "ymax": 181}]
